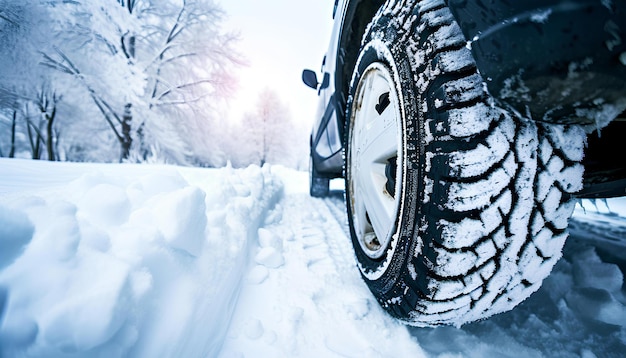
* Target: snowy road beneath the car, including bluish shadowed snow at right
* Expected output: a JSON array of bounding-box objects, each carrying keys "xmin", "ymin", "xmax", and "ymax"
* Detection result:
[{"xmin": 224, "ymin": 173, "xmax": 626, "ymax": 357}]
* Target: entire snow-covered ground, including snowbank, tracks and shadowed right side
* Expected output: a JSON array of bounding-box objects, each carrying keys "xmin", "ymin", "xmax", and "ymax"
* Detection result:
[{"xmin": 0, "ymin": 159, "xmax": 626, "ymax": 358}]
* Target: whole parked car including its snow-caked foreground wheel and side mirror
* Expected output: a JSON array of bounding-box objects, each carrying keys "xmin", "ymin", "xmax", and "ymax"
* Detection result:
[{"xmin": 303, "ymin": 0, "xmax": 626, "ymax": 325}]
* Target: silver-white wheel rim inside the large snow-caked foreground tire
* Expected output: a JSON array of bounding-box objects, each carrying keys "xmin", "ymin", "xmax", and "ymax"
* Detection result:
[{"xmin": 347, "ymin": 63, "xmax": 403, "ymax": 259}]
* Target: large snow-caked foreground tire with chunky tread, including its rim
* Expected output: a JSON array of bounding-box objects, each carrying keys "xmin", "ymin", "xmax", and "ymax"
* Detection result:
[{"xmin": 345, "ymin": 0, "xmax": 585, "ymax": 326}]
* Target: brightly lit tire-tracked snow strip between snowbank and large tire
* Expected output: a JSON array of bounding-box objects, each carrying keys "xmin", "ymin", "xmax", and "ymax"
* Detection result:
[{"xmin": 220, "ymin": 181, "xmax": 422, "ymax": 358}]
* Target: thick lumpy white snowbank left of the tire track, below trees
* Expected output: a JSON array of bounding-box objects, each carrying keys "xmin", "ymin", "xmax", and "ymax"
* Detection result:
[{"xmin": 0, "ymin": 160, "xmax": 281, "ymax": 357}]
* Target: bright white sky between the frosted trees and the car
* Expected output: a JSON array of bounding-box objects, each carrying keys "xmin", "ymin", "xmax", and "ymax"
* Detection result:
[{"xmin": 217, "ymin": 0, "xmax": 334, "ymax": 129}]
